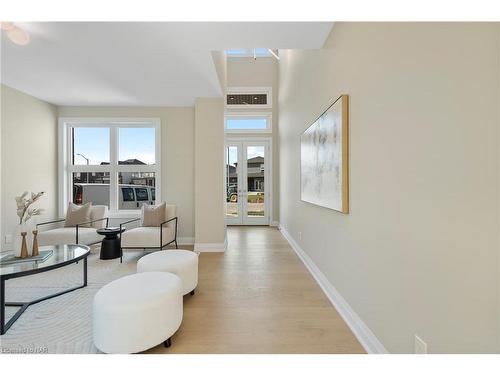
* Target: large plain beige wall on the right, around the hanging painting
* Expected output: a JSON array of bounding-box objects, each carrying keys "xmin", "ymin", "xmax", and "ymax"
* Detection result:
[{"xmin": 279, "ymin": 23, "xmax": 500, "ymax": 353}]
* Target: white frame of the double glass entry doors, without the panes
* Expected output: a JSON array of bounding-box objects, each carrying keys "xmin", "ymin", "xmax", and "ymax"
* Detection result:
[{"xmin": 224, "ymin": 137, "xmax": 273, "ymax": 225}]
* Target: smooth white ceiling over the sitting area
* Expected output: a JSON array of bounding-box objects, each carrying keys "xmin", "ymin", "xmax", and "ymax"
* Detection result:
[{"xmin": 1, "ymin": 22, "xmax": 332, "ymax": 106}]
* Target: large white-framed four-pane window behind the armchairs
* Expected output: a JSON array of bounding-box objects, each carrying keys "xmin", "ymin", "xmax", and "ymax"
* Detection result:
[{"xmin": 59, "ymin": 119, "xmax": 161, "ymax": 214}]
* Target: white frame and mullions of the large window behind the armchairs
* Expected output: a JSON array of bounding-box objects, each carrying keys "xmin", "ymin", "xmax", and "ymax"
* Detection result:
[{"xmin": 58, "ymin": 117, "xmax": 162, "ymax": 217}]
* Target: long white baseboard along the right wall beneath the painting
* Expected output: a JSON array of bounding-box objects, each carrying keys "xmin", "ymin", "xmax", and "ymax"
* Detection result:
[{"xmin": 279, "ymin": 225, "xmax": 388, "ymax": 354}]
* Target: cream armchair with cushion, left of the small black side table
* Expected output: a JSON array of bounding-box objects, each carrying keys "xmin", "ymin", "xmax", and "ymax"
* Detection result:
[{"xmin": 36, "ymin": 206, "xmax": 109, "ymax": 246}]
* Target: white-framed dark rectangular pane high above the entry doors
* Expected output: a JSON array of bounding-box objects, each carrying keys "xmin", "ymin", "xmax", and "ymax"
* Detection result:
[{"xmin": 226, "ymin": 87, "xmax": 272, "ymax": 109}]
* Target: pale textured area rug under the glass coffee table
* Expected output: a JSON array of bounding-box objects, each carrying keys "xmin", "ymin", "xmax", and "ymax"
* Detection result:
[{"xmin": 0, "ymin": 250, "xmax": 145, "ymax": 353}]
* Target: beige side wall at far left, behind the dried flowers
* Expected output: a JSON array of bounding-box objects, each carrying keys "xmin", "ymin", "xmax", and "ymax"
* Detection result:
[{"xmin": 0, "ymin": 85, "xmax": 57, "ymax": 250}]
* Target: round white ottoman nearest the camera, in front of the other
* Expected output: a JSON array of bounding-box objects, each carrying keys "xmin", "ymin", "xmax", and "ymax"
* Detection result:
[{"xmin": 92, "ymin": 272, "xmax": 182, "ymax": 353}]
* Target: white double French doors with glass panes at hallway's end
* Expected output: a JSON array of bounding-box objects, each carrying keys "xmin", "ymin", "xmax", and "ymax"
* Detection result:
[{"xmin": 225, "ymin": 141, "xmax": 270, "ymax": 225}]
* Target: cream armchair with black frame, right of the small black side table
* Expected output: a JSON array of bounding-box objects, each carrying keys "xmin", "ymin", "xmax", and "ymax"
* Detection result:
[{"xmin": 120, "ymin": 204, "xmax": 177, "ymax": 262}]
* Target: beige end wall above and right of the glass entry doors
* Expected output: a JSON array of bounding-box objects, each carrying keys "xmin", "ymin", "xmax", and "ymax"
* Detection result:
[{"xmin": 227, "ymin": 57, "xmax": 280, "ymax": 221}]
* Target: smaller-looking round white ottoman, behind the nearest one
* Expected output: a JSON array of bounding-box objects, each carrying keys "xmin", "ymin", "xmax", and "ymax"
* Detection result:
[{"xmin": 137, "ymin": 250, "xmax": 198, "ymax": 295}]
